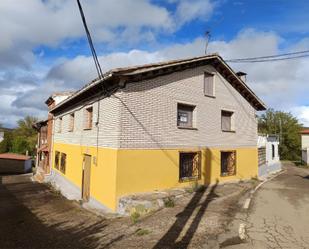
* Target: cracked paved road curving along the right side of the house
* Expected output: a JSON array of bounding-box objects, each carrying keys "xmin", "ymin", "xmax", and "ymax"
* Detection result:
[{"xmin": 226, "ymin": 162, "xmax": 309, "ymax": 249}]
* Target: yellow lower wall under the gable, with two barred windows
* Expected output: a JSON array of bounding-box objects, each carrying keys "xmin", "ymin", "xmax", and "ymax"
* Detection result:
[{"xmin": 117, "ymin": 148, "xmax": 258, "ymax": 197}]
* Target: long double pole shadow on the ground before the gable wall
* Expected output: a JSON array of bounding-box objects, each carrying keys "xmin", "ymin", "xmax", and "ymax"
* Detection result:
[{"xmin": 153, "ymin": 181, "xmax": 218, "ymax": 249}]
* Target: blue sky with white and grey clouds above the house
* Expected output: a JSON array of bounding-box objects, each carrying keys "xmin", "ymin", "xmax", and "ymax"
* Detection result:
[{"xmin": 0, "ymin": 0, "xmax": 309, "ymax": 128}]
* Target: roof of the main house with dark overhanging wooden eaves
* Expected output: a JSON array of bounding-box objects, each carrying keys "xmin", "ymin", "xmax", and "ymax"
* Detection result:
[{"xmin": 50, "ymin": 54, "xmax": 266, "ymax": 113}]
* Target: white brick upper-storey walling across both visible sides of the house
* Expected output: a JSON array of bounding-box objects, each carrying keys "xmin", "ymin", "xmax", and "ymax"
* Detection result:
[{"xmin": 54, "ymin": 66, "xmax": 257, "ymax": 148}]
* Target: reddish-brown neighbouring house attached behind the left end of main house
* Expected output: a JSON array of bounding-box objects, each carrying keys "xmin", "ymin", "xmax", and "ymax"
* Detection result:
[{"xmin": 33, "ymin": 92, "xmax": 72, "ymax": 181}]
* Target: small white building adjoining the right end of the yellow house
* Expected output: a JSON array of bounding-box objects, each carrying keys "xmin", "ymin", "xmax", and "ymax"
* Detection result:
[{"xmin": 258, "ymin": 135, "xmax": 281, "ymax": 177}]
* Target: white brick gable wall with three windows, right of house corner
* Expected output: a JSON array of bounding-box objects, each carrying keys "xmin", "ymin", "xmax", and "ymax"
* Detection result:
[{"xmin": 119, "ymin": 66, "xmax": 257, "ymax": 148}]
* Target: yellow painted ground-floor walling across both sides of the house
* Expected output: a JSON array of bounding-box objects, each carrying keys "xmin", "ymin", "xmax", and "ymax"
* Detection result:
[{"xmin": 53, "ymin": 144, "xmax": 258, "ymax": 211}]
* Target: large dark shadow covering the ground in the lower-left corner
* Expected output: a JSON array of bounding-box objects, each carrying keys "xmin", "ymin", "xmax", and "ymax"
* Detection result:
[{"xmin": 0, "ymin": 176, "xmax": 123, "ymax": 249}]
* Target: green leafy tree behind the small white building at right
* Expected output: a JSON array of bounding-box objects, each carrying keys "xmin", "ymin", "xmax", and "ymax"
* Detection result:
[{"xmin": 258, "ymin": 109, "xmax": 302, "ymax": 161}]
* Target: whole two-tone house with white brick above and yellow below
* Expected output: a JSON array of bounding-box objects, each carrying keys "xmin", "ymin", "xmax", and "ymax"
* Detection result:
[{"xmin": 50, "ymin": 54, "xmax": 265, "ymax": 211}]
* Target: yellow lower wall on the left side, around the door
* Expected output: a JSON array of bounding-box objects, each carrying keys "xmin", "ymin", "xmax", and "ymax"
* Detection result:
[{"xmin": 53, "ymin": 143, "xmax": 117, "ymax": 210}]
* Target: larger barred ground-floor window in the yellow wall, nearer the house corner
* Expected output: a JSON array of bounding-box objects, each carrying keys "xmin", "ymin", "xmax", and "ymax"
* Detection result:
[{"xmin": 179, "ymin": 152, "xmax": 201, "ymax": 180}]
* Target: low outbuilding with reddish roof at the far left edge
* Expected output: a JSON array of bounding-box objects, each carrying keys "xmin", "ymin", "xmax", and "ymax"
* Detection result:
[{"xmin": 0, "ymin": 153, "xmax": 32, "ymax": 174}]
